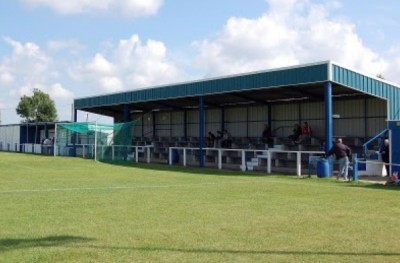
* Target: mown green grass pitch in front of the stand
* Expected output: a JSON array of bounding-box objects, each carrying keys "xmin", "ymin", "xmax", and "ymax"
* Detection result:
[{"xmin": 0, "ymin": 152, "xmax": 400, "ymax": 262}]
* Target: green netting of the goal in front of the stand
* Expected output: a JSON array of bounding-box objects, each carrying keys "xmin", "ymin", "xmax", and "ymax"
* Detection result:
[{"xmin": 54, "ymin": 120, "xmax": 138, "ymax": 160}]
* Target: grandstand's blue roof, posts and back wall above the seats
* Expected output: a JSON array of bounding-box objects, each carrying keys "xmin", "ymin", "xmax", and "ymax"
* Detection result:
[{"xmin": 74, "ymin": 61, "xmax": 400, "ymax": 174}]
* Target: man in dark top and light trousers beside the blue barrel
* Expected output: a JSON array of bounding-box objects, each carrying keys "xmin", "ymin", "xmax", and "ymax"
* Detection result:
[{"xmin": 326, "ymin": 138, "xmax": 351, "ymax": 181}]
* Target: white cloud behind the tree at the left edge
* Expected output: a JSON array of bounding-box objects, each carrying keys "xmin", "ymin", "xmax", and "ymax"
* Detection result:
[{"xmin": 0, "ymin": 37, "xmax": 77, "ymax": 123}]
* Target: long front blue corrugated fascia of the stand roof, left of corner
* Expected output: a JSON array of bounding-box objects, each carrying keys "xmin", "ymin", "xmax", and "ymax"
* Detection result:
[{"xmin": 74, "ymin": 62, "xmax": 328, "ymax": 110}]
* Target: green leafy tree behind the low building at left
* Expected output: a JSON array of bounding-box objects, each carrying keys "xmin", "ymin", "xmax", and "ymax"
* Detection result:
[{"xmin": 16, "ymin": 89, "xmax": 57, "ymax": 123}]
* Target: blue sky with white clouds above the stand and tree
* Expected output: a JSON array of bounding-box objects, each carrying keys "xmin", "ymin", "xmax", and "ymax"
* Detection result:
[{"xmin": 0, "ymin": 0, "xmax": 400, "ymax": 124}]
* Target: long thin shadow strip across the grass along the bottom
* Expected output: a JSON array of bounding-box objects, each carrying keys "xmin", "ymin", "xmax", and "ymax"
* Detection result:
[{"xmin": 84, "ymin": 246, "xmax": 400, "ymax": 257}]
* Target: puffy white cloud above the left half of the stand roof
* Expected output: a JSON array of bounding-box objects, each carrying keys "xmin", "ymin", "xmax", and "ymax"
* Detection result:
[{"xmin": 71, "ymin": 35, "xmax": 182, "ymax": 92}]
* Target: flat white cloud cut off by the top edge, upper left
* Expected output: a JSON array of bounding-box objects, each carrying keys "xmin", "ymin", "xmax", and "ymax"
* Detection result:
[{"xmin": 20, "ymin": 0, "xmax": 163, "ymax": 17}]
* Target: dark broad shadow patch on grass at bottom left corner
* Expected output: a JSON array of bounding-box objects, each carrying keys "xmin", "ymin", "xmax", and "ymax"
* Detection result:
[{"xmin": 0, "ymin": 236, "xmax": 93, "ymax": 251}]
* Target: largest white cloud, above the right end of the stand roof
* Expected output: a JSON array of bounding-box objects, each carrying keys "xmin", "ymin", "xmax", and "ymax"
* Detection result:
[{"xmin": 193, "ymin": 0, "xmax": 388, "ymax": 80}]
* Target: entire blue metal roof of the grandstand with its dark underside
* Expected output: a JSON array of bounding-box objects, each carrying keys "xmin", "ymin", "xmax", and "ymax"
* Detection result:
[{"xmin": 74, "ymin": 61, "xmax": 400, "ymax": 120}]
